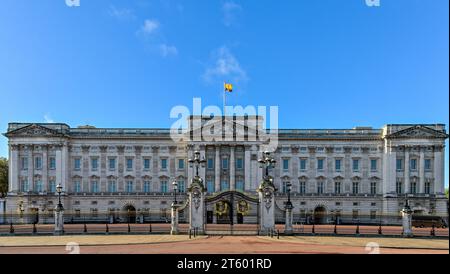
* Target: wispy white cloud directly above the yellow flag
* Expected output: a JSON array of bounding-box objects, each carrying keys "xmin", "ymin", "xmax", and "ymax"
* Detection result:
[{"xmin": 203, "ymin": 46, "xmax": 248, "ymax": 83}]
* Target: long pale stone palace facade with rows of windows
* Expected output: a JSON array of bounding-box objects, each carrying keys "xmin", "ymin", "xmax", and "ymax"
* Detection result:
[{"xmin": 0, "ymin": 116, "xmax": 448, "ymax": 224}]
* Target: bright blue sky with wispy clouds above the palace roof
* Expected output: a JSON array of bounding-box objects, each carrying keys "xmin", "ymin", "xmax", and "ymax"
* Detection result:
[{"xmin": 0, "ymin": 0, "xmax": 449, "ymax": 185}]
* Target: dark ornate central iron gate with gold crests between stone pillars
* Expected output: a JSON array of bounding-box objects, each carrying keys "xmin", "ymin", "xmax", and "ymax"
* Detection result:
[{"xmin": 204, "ymin": 191, "xmax": 260, "ymax": 235}]
